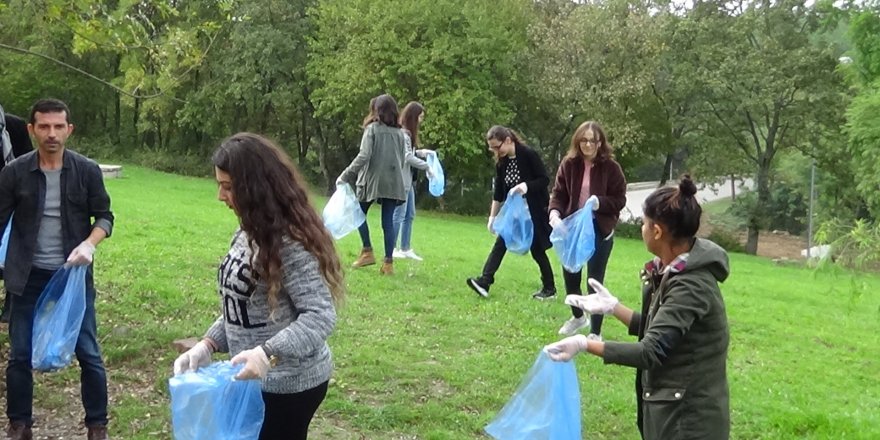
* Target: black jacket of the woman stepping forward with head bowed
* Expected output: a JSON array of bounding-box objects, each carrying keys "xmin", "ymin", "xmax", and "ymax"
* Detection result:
[{"xmin": 492, "ymin": 144, "xmax": 552, "ymax": 251}]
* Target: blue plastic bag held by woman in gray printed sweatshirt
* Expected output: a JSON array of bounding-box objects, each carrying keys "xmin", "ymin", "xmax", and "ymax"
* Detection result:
[{"xmin": 168, "ymin": 361, "xmax": 266, "ymax": 440}]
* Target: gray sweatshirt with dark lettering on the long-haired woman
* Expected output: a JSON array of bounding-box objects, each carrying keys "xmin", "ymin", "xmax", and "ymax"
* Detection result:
[{"xmin": 205, "ymin": 229, "xmax": 336, "ymax": 394}]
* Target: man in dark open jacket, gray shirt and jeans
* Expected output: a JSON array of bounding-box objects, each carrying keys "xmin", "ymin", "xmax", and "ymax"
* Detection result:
[{"xmin": 0, "ymin": 99, "xmax": 113, "ymax": 440}]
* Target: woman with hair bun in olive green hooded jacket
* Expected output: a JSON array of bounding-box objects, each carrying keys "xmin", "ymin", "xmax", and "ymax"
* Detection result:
[{"xmin": 545, "ymin": 176, "xmax": 730, "ymax": 440}]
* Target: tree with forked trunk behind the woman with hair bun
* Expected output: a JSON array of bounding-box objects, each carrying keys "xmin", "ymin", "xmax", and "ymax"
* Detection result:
[{"xmin": 686, "ymin": 0, "xmax": 845, "ymax": 254}]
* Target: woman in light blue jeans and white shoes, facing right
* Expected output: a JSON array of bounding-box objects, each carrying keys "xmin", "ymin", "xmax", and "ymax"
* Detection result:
[{"xmin": 394, "ymin": 101, "xmax": 431, "ymax": 261}]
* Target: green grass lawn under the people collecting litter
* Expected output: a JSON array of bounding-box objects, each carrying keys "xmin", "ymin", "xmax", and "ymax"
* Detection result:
[{"xmin": 6, "ymin": 166, "xmax": 880, "ymax": 439}]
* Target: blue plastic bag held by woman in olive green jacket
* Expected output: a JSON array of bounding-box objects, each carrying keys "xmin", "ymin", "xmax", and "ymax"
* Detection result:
[{"xmin": 486, "ymin": 351, "xmax": 581, "ymax": 440}]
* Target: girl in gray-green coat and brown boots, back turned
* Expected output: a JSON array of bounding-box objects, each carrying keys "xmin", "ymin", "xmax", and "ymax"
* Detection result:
[{"xmin": 336, "ymin": 95, "xmax": 406, "ymax": 275}]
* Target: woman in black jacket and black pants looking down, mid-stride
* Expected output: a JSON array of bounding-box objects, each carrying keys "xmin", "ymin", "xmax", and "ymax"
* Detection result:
[{"xmin": 467, "ymin": 125, "xmax": 556, "ymax": 299}]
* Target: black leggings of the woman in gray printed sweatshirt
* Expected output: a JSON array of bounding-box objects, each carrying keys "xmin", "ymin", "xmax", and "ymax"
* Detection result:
[{"xmin": 260, "ymin": 381, "xmax": 330, "ymax": 440}]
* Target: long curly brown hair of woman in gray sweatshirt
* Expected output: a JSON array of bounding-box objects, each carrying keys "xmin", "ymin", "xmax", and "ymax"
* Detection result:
[{"xmin": 212, "ymin": 133, "xmax": 345, "ymax": 311}]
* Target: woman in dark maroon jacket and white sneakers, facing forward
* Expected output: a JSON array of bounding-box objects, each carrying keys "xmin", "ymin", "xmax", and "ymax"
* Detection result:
[{"xmin": 550, "ymin": 121, "xmax": 626, "ymax": 341}]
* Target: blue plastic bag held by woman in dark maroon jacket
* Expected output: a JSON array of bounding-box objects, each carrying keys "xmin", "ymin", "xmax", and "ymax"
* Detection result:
[{"xmin": 550, "ymin": 201, "xmax": 596, "ymax": 273}]
